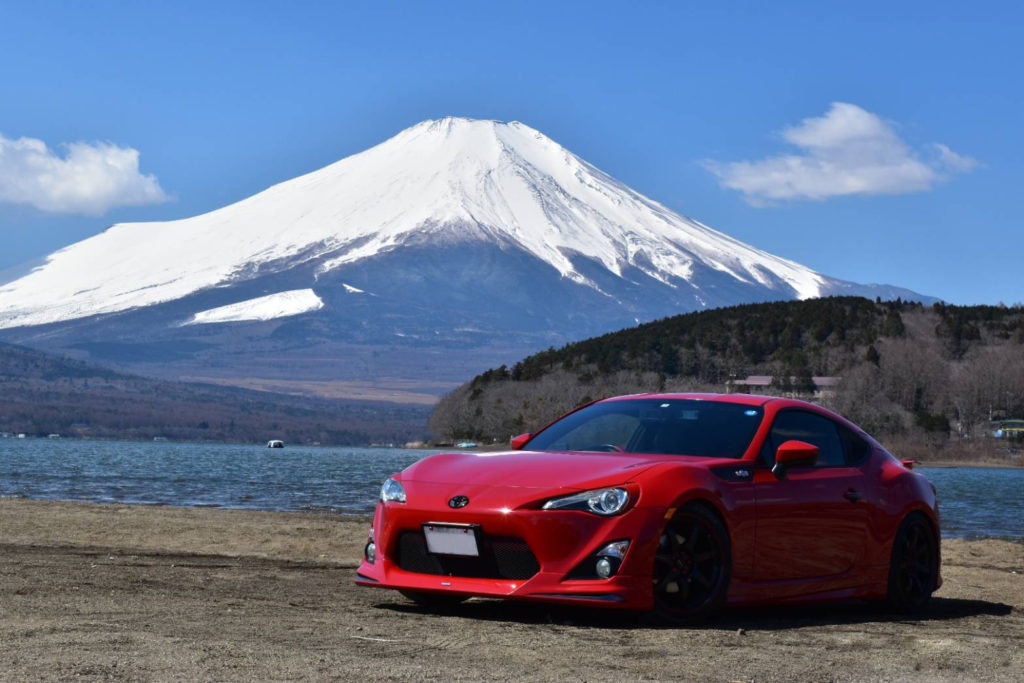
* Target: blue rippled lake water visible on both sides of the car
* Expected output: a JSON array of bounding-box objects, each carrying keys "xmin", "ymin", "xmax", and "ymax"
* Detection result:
[{"xmin": 0, "ymin": 438, "xmax": 1024, "ymax": 539}]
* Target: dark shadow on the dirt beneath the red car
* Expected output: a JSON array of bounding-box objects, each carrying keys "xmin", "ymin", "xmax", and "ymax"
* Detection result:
[{"xmin": 376, "ymin": 597, "xmax": 1013, "ymax": 631}]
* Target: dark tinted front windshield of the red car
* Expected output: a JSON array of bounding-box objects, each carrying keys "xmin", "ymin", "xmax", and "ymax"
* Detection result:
[{"xmin": 525, "ymin": 398, "xmax": 764, "ymax": 458}]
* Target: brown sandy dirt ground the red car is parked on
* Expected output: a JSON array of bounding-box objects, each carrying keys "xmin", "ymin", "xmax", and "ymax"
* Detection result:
[{"xmin": 0, "ymin": 499, "xmax": 1024, "ymax": 681}]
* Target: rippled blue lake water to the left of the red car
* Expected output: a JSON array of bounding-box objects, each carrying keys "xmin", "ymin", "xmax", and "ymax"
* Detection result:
[{"xmin": 0, "ymin": 439, "xmax": 433, "ymax": 513}]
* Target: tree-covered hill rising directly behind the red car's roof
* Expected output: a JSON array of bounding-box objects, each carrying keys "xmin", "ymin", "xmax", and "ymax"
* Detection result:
[{"xmin": 431, "ymin": 297, "xmax": 1024, "ymax": 454}]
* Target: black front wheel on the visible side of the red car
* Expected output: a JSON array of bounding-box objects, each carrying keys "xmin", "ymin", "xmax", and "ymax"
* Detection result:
[{"xmin": 651, "ymin": 504, "xmax": 732, "ymax": 626}]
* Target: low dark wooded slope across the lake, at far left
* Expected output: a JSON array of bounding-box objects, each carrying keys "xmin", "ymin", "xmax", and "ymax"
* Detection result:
[{"xmin": 0, "ymin": 344, "xmax": 427, "ymax": 444}]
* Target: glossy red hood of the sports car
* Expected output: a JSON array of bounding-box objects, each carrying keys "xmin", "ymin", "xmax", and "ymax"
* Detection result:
[{"xmin": 401, "ymin": 451, "xmax": 688, "ymax": 489}]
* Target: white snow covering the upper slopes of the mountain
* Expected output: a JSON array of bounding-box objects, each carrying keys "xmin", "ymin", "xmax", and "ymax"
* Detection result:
[{"xmin": 0, "ymin": 118, "xmax": 848, "ymax": 328}]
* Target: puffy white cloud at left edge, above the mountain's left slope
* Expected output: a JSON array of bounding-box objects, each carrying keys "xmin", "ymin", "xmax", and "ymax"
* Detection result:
[{"xmin": 0, "ymin": 135, "xmax": 168, "ymax": 210}]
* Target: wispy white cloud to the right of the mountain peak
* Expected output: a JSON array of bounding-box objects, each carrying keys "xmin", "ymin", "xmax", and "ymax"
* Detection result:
[{"xmin": 705, "ymin": 102, "xmax": 978, "ymax": 206}]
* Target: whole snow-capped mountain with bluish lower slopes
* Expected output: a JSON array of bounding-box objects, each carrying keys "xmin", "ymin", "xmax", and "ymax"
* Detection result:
[{"xmin": 0, "ymin": 118, "xmax": 931, "ymax": 391}]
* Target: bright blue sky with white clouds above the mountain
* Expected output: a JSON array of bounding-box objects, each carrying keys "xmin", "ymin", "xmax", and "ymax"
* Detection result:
[{"xmin": 0, "ymin": 0, "xmax": 1024, "ymax": 303}]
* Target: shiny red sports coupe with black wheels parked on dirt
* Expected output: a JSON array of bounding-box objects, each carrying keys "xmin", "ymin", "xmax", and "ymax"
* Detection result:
[{"xmin": 356, "ymin": 394, "xmax": 941, "ymax": 623}]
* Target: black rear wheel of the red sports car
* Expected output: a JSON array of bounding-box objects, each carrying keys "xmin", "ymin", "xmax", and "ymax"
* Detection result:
[{"xmin": 887, "ymin": 512, "xmax": 939, "ymax": 613}]
